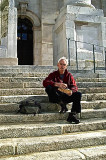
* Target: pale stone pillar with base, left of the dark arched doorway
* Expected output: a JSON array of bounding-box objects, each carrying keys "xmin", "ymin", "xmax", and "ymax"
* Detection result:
[{"xmin": 0, "ymin": 0, "xmax": 18, "ymax": 65}]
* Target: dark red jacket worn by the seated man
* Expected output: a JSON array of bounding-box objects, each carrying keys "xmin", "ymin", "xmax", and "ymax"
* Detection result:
[{"xmin": 43, "ymin": 69, "xmax": 78, "ymax": 93}]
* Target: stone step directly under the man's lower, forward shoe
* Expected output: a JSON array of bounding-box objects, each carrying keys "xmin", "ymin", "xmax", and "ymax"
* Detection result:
[{"xmin": 0, "ymin": 118, "xmax": 106, "ymax": 139}]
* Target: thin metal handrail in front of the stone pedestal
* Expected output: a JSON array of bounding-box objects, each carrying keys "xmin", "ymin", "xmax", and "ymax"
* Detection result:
[{"xmin": 66, "ymin": 38, "xmax": 106, "ymax": 73}]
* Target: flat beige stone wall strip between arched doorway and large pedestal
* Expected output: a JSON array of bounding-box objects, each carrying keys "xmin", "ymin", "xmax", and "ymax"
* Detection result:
[{"xmin": 41, "ymin": 0, "xmax": 59, "ymax": 65}]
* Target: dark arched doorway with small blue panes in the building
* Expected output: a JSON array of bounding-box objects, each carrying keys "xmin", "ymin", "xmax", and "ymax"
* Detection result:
[{"xmin": 17, "ymin": 18, "xmax": 33, "ymax": 65}]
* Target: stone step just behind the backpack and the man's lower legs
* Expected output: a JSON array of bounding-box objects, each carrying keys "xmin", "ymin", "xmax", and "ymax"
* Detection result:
[{"xmin": 0, "ymin": 100, "xmax": 106, "ymax": 113}]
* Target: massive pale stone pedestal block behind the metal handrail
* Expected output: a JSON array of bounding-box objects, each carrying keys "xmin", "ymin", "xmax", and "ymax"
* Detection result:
[{"xmin": 54, "ymin": 5, "xmax": 106, "ymax": 67}]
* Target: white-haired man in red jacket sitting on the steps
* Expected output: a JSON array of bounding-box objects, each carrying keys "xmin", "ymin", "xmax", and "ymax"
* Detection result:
[{"xmin": 43, "ymin": 57, "xmax": 81, "ymax": 124}]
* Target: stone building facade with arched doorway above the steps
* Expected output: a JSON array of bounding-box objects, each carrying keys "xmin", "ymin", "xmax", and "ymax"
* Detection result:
[{"xmin": 0, "ymin": 0, "xmax": 106, "ymax": 68}]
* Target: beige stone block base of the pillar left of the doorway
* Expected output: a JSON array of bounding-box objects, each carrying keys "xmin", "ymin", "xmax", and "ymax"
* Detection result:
[{"xmin": 0, "ymin": 58, "xmax": 18, "ymax": 66}]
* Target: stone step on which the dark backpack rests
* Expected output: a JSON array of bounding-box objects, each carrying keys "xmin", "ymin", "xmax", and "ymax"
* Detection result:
[{"xmin": 0, "ymin": 108, "xmax": 106, "ymax": 124}]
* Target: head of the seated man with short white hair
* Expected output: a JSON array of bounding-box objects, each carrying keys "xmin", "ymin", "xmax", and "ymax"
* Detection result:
[{"xmin": 57, "ymin": 57, "xmax": 68, "ymax": 74}]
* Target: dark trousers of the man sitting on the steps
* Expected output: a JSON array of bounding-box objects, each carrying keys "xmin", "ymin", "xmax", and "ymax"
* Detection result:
[{"xmin": 45, "ymin": 85, "xmax": 82, "ymax": 113}]
